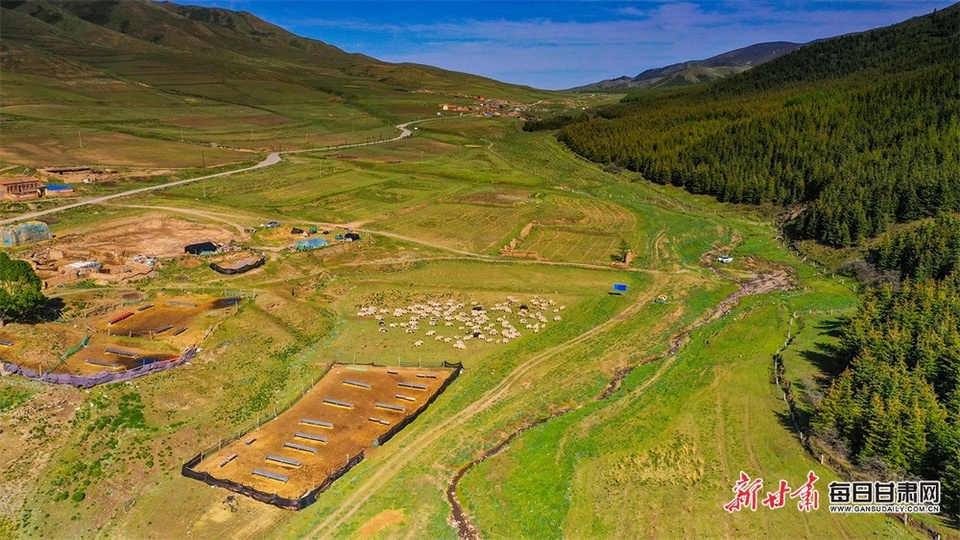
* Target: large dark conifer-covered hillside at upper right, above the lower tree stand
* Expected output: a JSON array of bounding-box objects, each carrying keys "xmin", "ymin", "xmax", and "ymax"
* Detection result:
[{"xmin": 559, "ymin": 5, "xmax": 960, "ymax": 247}]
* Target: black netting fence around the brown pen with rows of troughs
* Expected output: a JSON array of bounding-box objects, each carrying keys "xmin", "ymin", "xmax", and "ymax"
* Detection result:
[{"xmin": 180, "ymin": 360, "xmax": 463, "ymax": 510}]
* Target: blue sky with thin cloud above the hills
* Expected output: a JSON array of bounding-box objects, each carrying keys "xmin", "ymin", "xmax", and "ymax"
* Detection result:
[{"xmin": 184, "ymin": 0, "xmax": 951, "ymax": 89}]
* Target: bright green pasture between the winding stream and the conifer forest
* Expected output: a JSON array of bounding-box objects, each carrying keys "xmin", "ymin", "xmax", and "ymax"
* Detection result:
[{"xmin": 461, "ymin": 303, "xmax": 924, "ymax": 538}]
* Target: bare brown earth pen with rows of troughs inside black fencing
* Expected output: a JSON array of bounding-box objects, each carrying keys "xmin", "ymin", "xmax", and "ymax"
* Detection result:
[{"xmin": 194, "ymin": 365, "xmax": 455, "ymax": 499}]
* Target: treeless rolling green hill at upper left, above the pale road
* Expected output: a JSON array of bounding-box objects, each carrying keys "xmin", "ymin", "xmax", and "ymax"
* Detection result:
[{"xmin": 0, "ymin": 0, "xmax": 552, "ymax": 166}]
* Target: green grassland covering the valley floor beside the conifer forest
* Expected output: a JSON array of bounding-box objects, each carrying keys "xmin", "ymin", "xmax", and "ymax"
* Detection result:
[{"xmin": 0, "ymin": 105, "xmax": 949, "ymax": 538}]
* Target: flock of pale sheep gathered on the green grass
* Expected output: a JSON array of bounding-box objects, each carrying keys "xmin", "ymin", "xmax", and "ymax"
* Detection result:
[{"xmin": 357, "ymin": 296, "xmax": 567, "ymax": 350}]
